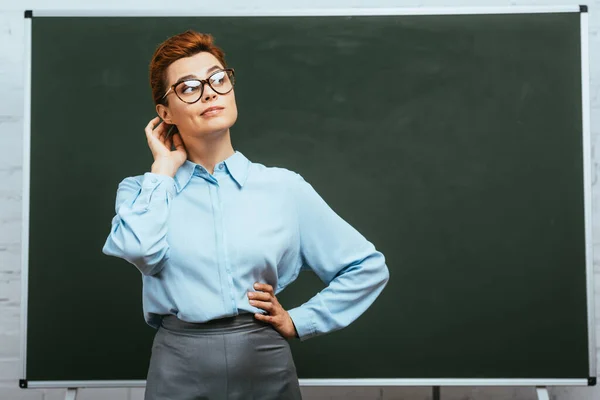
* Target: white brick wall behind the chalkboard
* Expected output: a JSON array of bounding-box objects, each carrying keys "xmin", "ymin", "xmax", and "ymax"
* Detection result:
[{"xmin": 0, "ymin": 0, "xmax": 600, "ymax": 400}]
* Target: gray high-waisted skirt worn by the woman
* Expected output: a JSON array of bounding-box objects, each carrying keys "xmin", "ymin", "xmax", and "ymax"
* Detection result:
[{"xmin": 144, "ymin": 314, "xmax": 302, "ymax": 400}]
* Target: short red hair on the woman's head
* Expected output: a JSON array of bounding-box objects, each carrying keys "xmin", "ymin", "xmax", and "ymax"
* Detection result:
[{"xmin": 150, "ymin": 30, "xmax": 227, "ymax": 105}]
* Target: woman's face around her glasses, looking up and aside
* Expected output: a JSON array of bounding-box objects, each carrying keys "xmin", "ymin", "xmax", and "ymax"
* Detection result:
[{"xmin": 156, "ymin": 52, "xmax": 237, "ymax": 137}]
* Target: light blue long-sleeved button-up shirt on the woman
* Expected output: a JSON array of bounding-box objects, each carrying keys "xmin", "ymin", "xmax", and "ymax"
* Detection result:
[{"xmin": 102, "ymin": 152, "xmax": 389, "ymax": 340}]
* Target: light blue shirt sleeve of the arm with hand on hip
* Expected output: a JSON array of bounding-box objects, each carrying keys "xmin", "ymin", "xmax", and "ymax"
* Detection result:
[{"xmin": 288, "ymin": 174, "xmax": 389, "ymax": 340}]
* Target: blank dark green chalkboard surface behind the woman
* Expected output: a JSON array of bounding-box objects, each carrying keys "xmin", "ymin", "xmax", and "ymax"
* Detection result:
[{"xmin": 24, "ymin": 12, "xmax": 590, "ymax": 381}]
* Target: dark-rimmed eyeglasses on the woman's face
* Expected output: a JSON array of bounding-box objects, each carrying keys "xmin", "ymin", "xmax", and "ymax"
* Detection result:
[{"xmin": 162, "ymin": 68, "xmax": 235, "ymax": 104}]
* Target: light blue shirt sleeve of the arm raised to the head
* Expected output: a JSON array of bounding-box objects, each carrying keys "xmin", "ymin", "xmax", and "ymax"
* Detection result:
[{"xmin": 102, "ymin": 172, "xmax": 176, "ymax": 275}]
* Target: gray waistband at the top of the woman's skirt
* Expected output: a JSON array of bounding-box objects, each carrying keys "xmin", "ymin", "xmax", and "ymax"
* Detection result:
[{"xmin": 161, "ymin": 313, "xmax": 271, "ymax": 335}]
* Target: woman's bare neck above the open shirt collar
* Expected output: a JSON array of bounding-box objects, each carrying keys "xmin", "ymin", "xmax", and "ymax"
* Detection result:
[{"xmin": 183, "ymin": 129, "xmax": 235, "ymax": 174}]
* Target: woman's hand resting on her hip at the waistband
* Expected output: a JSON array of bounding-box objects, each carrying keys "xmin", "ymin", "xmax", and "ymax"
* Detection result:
[{"xmin": 248, "ymin": 282, "xmax": 297, "ymax": 339}]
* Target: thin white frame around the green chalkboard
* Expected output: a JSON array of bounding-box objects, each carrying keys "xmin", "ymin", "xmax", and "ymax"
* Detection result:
[{"xmin": 20, "ymin": 6, "xmax": 597, "ymax": 388}]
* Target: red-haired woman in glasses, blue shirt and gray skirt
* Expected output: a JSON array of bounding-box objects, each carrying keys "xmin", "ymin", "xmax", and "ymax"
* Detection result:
[{"xmin": 103, "ymin": 31, "xmax": 388, "ymax": 400}]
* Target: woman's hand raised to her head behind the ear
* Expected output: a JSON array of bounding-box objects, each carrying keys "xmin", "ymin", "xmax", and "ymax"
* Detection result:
[{"xmin": 145, "ymin": 117, "xmax": 187, "ymax": 177}]
